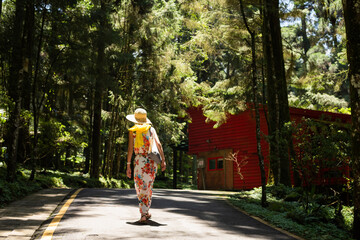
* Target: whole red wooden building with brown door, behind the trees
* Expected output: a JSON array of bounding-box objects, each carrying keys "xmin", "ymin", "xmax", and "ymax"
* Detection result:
[{"xmin": 189, "ymin": 108, "xmax": 350, "ymax": 190}]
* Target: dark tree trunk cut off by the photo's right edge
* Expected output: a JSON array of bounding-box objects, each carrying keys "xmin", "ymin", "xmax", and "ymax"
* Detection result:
[{"xmin": 342, "ymin": 0, "xmax": 360, "ymax": 239}]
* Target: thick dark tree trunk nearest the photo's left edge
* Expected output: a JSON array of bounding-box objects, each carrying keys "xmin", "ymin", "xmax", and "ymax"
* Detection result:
[{"xmin": 6, "ymin": 0, "xmax": 25, "ymax": 182}]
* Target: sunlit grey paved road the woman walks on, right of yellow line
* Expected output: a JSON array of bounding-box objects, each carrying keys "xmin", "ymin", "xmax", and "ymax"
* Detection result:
[{"xmin": 36, "ymin": 189, "xmax": 294, "ymax": 240}]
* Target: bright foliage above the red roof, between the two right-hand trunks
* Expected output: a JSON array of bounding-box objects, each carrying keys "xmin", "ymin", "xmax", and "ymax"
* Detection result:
[{"xmin": 282, "ymin": 0, "xmax": 349, "ymax": 112}]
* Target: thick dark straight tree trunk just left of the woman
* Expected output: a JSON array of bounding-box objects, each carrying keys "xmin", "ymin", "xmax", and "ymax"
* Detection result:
[{"xmin": 90, "ymin": 1, "xmax": 106, "ymax": 178}]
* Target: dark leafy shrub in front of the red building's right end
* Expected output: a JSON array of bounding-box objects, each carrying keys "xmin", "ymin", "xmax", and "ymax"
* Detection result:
[{"xmin": 289, "ymin": 118, "xmax": 352, "ymax": 221}]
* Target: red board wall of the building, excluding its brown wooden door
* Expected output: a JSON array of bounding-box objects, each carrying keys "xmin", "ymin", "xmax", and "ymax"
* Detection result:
[{"xmin": 188, "ymin": 108, "xmax": 351, "ymax": 189}]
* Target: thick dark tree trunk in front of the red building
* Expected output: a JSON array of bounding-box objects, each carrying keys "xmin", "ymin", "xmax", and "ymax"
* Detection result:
[{"xmin": 263, "ymin": 0, "xmax": 291, "ymax": 185}]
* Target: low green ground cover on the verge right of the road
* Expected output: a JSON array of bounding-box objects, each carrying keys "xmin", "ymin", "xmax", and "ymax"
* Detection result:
[{"xmin": 229, "ymin": 186, "xmax": 353, "ymax": 240}]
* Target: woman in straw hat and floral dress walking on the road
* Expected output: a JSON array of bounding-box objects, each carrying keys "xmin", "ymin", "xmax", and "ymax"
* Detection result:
[{"xmin": 126, "ymin": 108, "xmax": 166, "ymax": 223}]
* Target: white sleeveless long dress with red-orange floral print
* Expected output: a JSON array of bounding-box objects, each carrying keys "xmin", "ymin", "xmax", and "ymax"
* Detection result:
[{"xmin": 133, "ymin": 128, "xmax": 157, "ymax": 215}]
